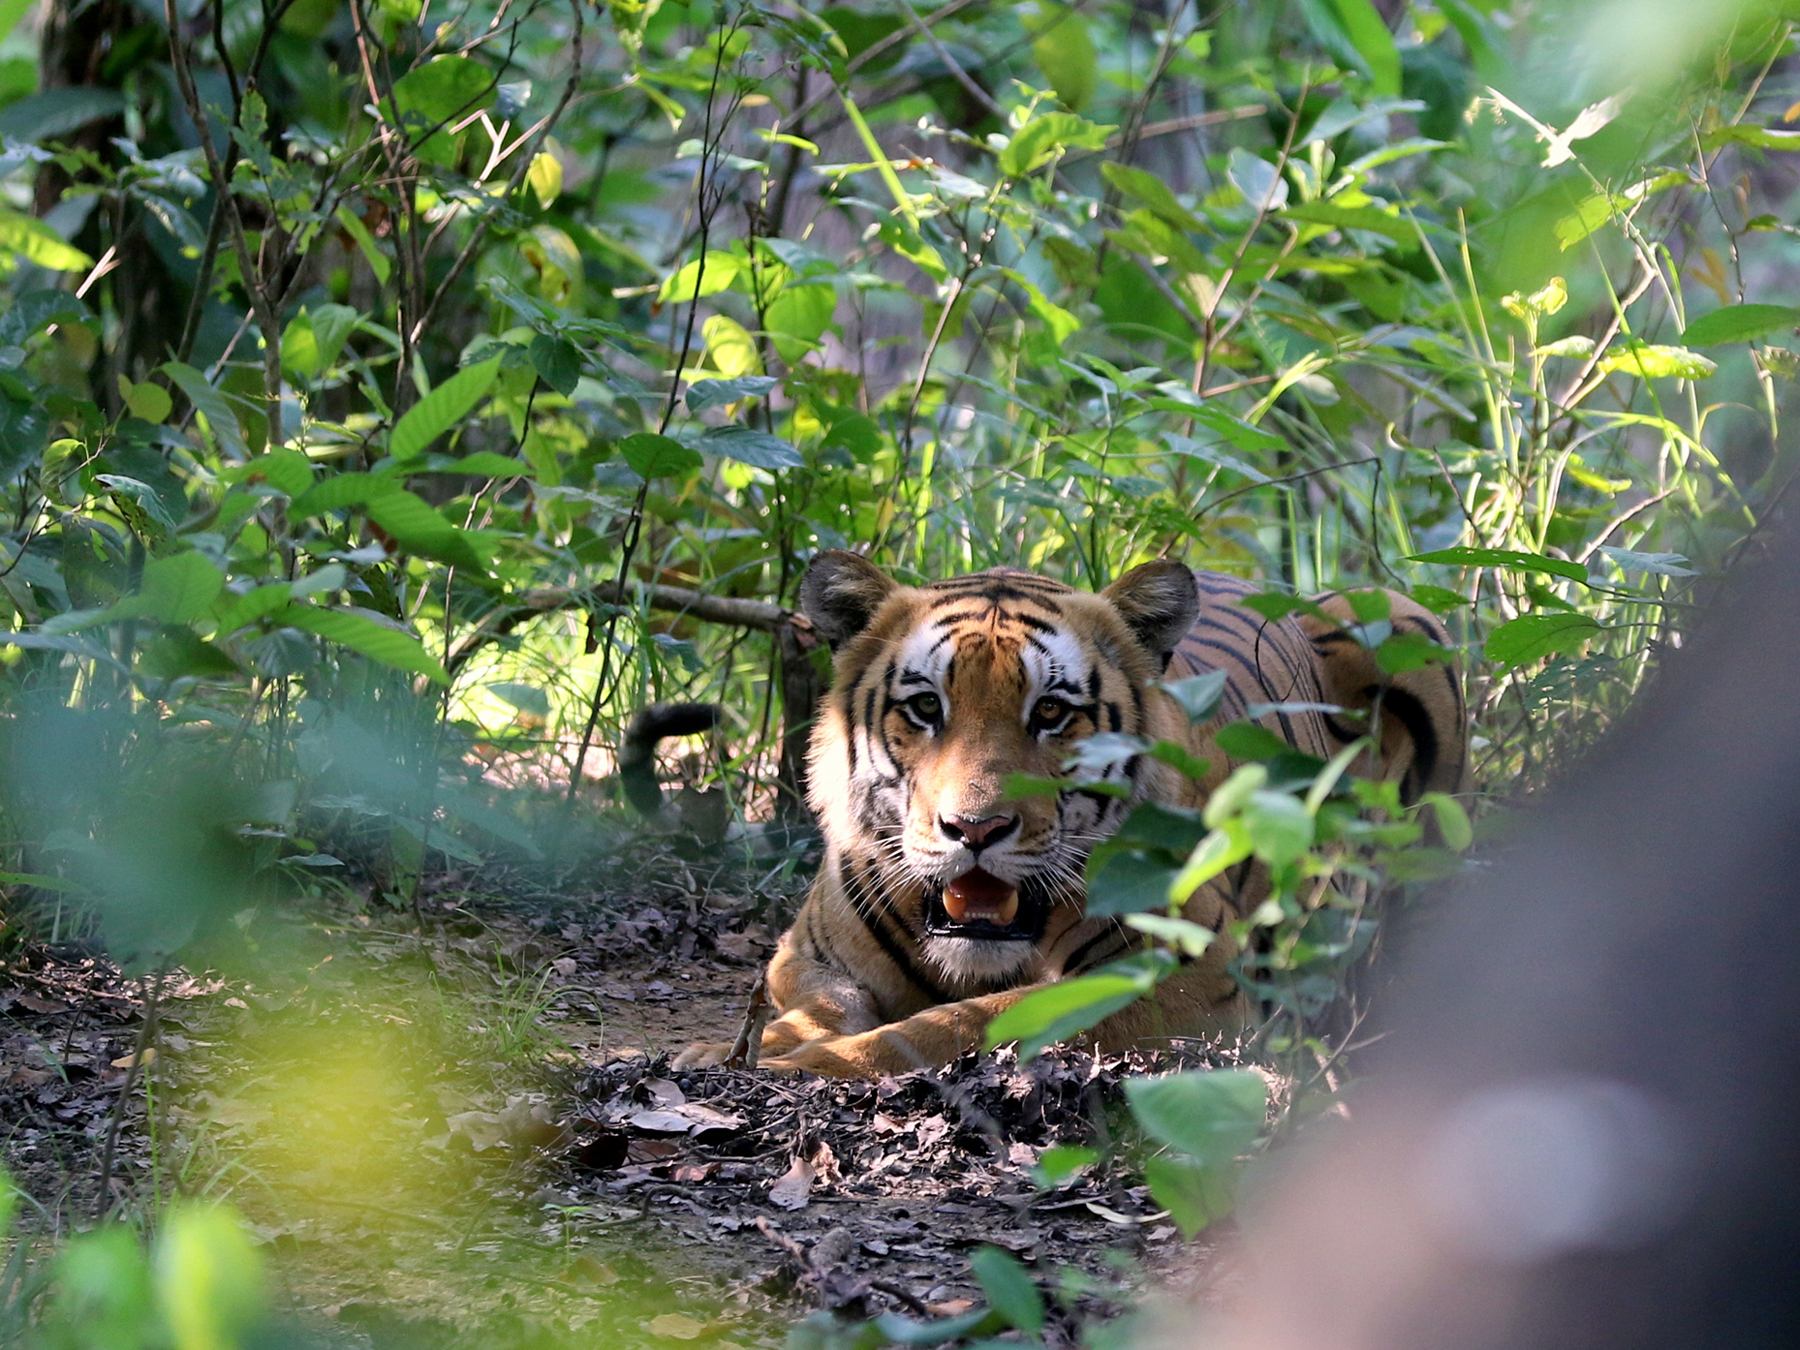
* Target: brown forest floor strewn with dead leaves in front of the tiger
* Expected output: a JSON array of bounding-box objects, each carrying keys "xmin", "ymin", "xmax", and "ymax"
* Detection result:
[{"xmin": 0, "ymin": 850, "xmax": 1224, "ymax": 1350}]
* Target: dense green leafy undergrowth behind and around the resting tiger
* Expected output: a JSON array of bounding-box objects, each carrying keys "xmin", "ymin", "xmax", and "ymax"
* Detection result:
[{"xmin": 0, "ymin": 0, "xmax": 1800, "ymax": 1346}]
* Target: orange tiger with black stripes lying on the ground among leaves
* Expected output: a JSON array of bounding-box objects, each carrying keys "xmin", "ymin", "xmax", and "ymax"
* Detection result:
[{"xmin": 677, "ymin": 549, "xmax": 1469, "ymax": 1078}]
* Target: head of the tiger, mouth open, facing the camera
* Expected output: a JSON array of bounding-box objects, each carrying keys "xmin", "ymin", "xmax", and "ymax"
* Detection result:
[{"xmin": 801, "ymin": 551, "xmax": 1199, "ymax": 979}]
